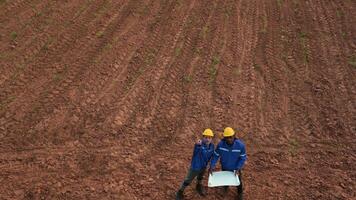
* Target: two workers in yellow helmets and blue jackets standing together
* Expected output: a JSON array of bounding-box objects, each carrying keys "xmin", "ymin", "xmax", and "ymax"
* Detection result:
[{"xmin": 176, "ymin": 127, "xmax": 246, "ymax": 200}]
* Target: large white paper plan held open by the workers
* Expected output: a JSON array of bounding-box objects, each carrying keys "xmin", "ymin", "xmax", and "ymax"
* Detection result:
[{"xmin": 208, "ymin": 171, "xmax": 240, "ymax": 187}]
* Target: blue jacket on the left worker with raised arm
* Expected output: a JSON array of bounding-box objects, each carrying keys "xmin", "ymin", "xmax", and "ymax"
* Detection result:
[{"xmin": 191, "ymin": 143, "xmax": 214, "ymax": 170}]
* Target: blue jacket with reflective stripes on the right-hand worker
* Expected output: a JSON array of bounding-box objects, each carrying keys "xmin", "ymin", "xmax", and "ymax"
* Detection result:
[{"xmin": 210, "ymin": 139, "xmax": 247, "ymax": 171}]
